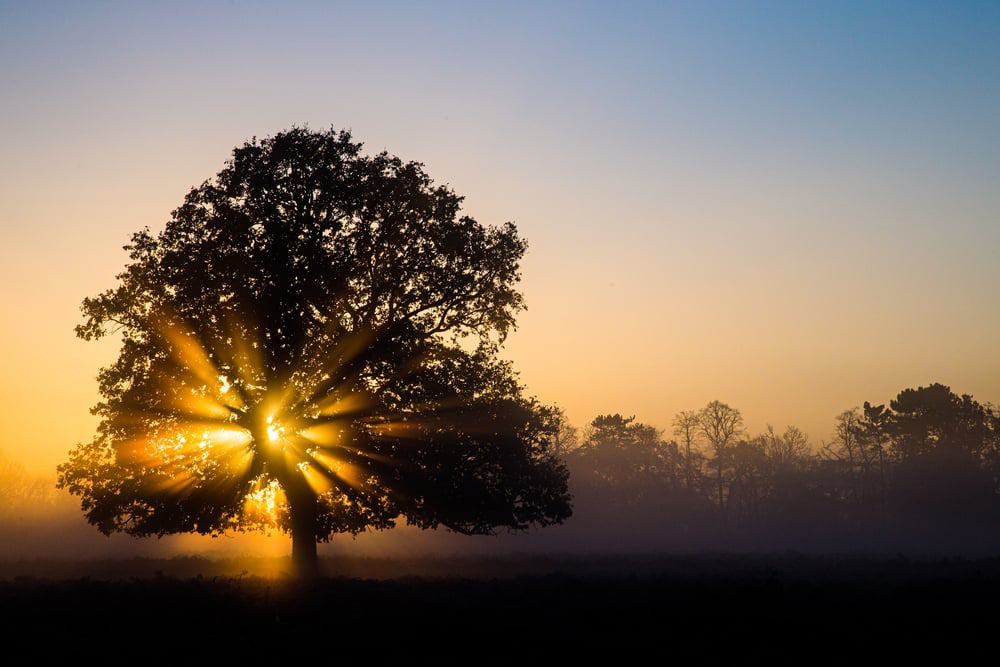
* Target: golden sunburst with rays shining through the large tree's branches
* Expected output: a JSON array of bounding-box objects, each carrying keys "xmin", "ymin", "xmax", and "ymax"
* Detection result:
[{"xmin": 121, "ymin": 308, "xmax": 395, "ymax": 528}]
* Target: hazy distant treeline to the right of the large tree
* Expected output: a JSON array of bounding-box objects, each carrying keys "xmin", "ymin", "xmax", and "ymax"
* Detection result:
[{"xmin": 556, "ymin": 384, "xmax": 1000, "ymax": 552}]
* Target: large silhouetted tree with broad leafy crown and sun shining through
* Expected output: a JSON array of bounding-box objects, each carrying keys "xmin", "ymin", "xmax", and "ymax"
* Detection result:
[{"xmin": 60, "ymin": 129, "xmax": 570, "ymax": 573}]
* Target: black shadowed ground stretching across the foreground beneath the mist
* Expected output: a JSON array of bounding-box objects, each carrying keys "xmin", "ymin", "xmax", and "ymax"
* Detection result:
[{"xmin": 0, "ymin": 555, "xmax": 1000, "ymax": 664}]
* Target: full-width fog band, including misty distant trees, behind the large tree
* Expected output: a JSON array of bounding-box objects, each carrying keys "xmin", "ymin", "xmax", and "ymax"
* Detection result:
[{"xmin": 0, "ymin": 385, "xmax": 1000, "ymax": 561}]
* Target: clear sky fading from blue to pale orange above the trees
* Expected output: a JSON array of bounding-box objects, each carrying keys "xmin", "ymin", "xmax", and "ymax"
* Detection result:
[{"xmin": 0, "ymin": 1, "xmax": 1000, "ymax": 471}]
